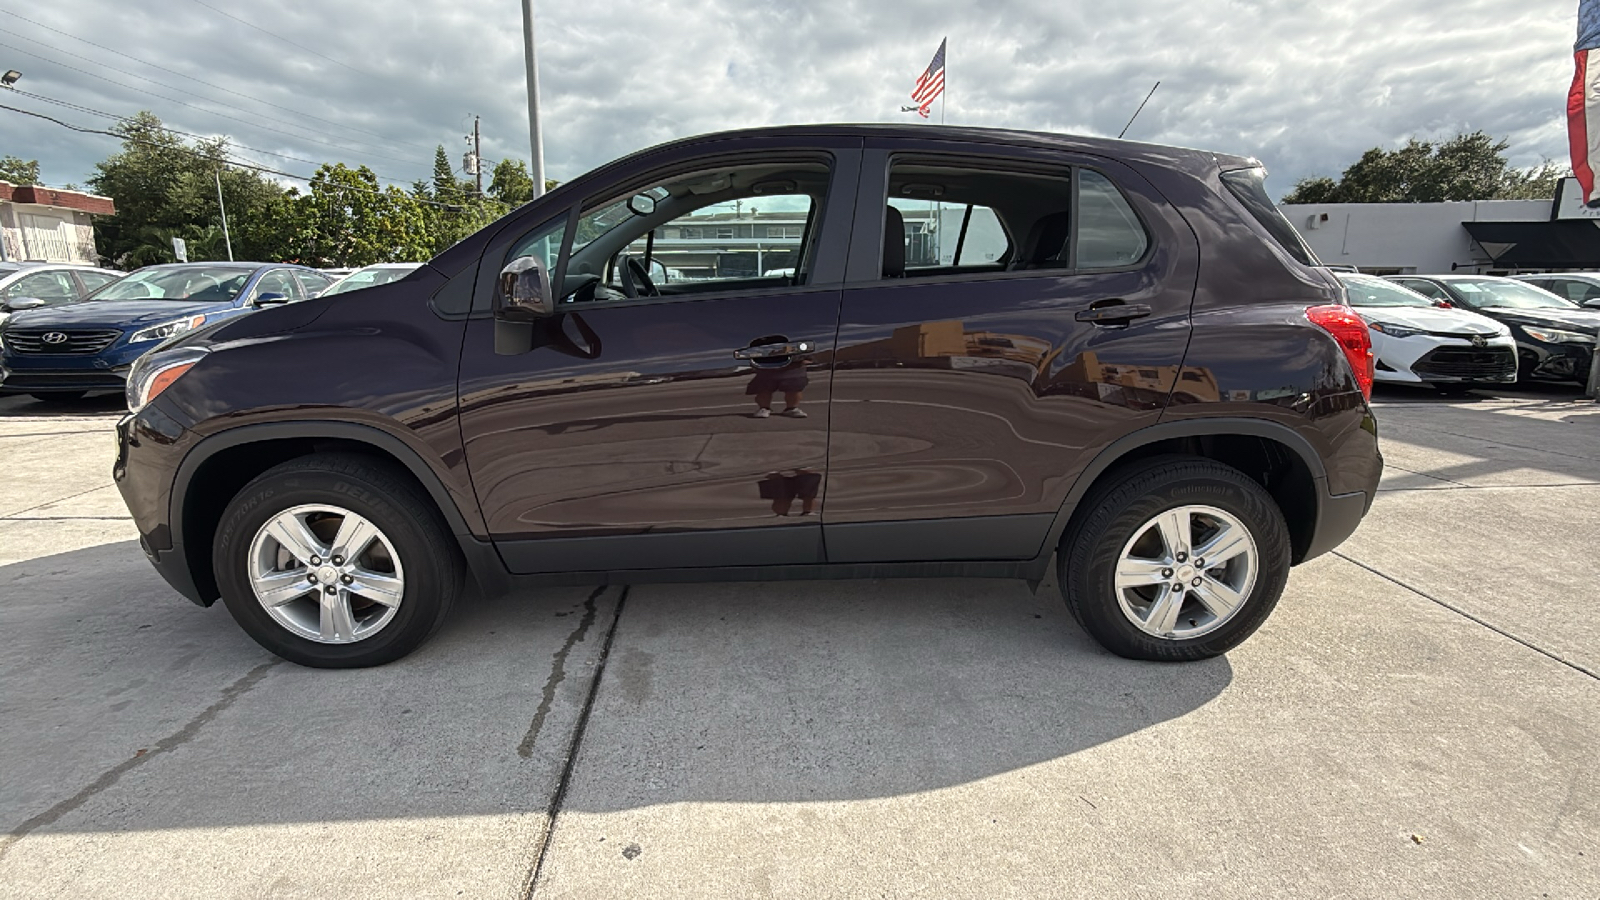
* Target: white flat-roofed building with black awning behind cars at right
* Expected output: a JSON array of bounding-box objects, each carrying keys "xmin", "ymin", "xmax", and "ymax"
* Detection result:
[{"xmin": 1278, "ymin": 179, "xmax": 1600, "ymax": 275}]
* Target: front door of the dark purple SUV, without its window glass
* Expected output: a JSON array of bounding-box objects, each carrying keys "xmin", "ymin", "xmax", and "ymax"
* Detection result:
[{"xmin": 459, "ymin": 141, "xmax": 859, "ymax": 572}]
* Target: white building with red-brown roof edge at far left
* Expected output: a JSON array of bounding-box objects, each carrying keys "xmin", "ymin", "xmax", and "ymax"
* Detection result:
[{"xmin": 0, "ymin": 181, "xmax": 117, "ymax": 266}]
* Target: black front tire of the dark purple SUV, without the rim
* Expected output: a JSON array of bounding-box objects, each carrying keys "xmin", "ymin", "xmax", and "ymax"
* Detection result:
[{"xmin": 213, "ymin": 453, "xmax": 464, "ymax": 669}]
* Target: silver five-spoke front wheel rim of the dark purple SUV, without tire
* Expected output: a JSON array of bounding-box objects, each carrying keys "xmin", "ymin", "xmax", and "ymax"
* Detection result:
[{"xmin": 250, "ymin": 504, "xmax": 405, "ymax": 644}]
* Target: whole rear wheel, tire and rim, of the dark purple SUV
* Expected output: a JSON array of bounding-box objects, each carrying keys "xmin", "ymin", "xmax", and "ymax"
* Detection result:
[{"xmin": 1058, "ymin": 456, "xmax": 1290, "ymax": 661}]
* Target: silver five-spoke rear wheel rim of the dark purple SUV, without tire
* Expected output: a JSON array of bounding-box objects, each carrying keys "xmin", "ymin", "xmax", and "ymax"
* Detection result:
[{"xmin": 1114, "ymin": 506, "xmax": 1261, "ymax": 641}]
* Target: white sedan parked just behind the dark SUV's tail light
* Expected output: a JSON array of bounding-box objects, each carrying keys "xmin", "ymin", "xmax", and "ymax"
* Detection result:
[{"xmin": 1338, "ymin": 272, "xmax": 1517, "ymax": 392}]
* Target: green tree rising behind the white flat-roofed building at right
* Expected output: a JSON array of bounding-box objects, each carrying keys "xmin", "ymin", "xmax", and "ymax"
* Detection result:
[{"xmin": 1283, "ymin": 131, "xmax": 1566, "ymax": 203}]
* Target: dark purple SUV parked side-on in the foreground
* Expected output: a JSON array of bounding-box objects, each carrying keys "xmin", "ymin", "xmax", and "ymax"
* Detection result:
[{"xmin": 115, "ymin": 127, "xmax": 1382, "ymax": 666}]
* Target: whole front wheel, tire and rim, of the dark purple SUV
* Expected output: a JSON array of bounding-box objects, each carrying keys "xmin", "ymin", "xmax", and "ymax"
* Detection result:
[{"xmin": 213, "ymin": 455, "xmax": 462, "ymax": 668}]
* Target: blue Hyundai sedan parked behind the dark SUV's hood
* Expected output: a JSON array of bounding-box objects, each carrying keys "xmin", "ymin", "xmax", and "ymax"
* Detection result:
[{"xmin": 0, "ymin": 263, "xmax": 333, "ymax": 400}]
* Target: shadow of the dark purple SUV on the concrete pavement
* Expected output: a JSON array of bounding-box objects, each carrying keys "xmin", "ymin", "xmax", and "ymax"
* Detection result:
[{"xmin": 0, "ymin": 543, "xmax": 1232, "ymax": 832}]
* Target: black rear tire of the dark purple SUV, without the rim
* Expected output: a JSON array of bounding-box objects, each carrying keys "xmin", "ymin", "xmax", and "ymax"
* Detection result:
[{"xmin": 1056, "ymin": 456, "xmax": 1291, "ymax": 661}]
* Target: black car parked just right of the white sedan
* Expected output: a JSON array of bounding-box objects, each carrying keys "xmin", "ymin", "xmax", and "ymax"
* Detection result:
[{"xmin": 1389, "ymin": 275, "xmax": 1600, "ymax": 384}]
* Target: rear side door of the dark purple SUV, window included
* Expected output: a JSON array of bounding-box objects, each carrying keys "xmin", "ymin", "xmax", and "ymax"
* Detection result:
[{"xmin": 822, "ymin": 139, "xmax": 1216, "ymax": 562}]
